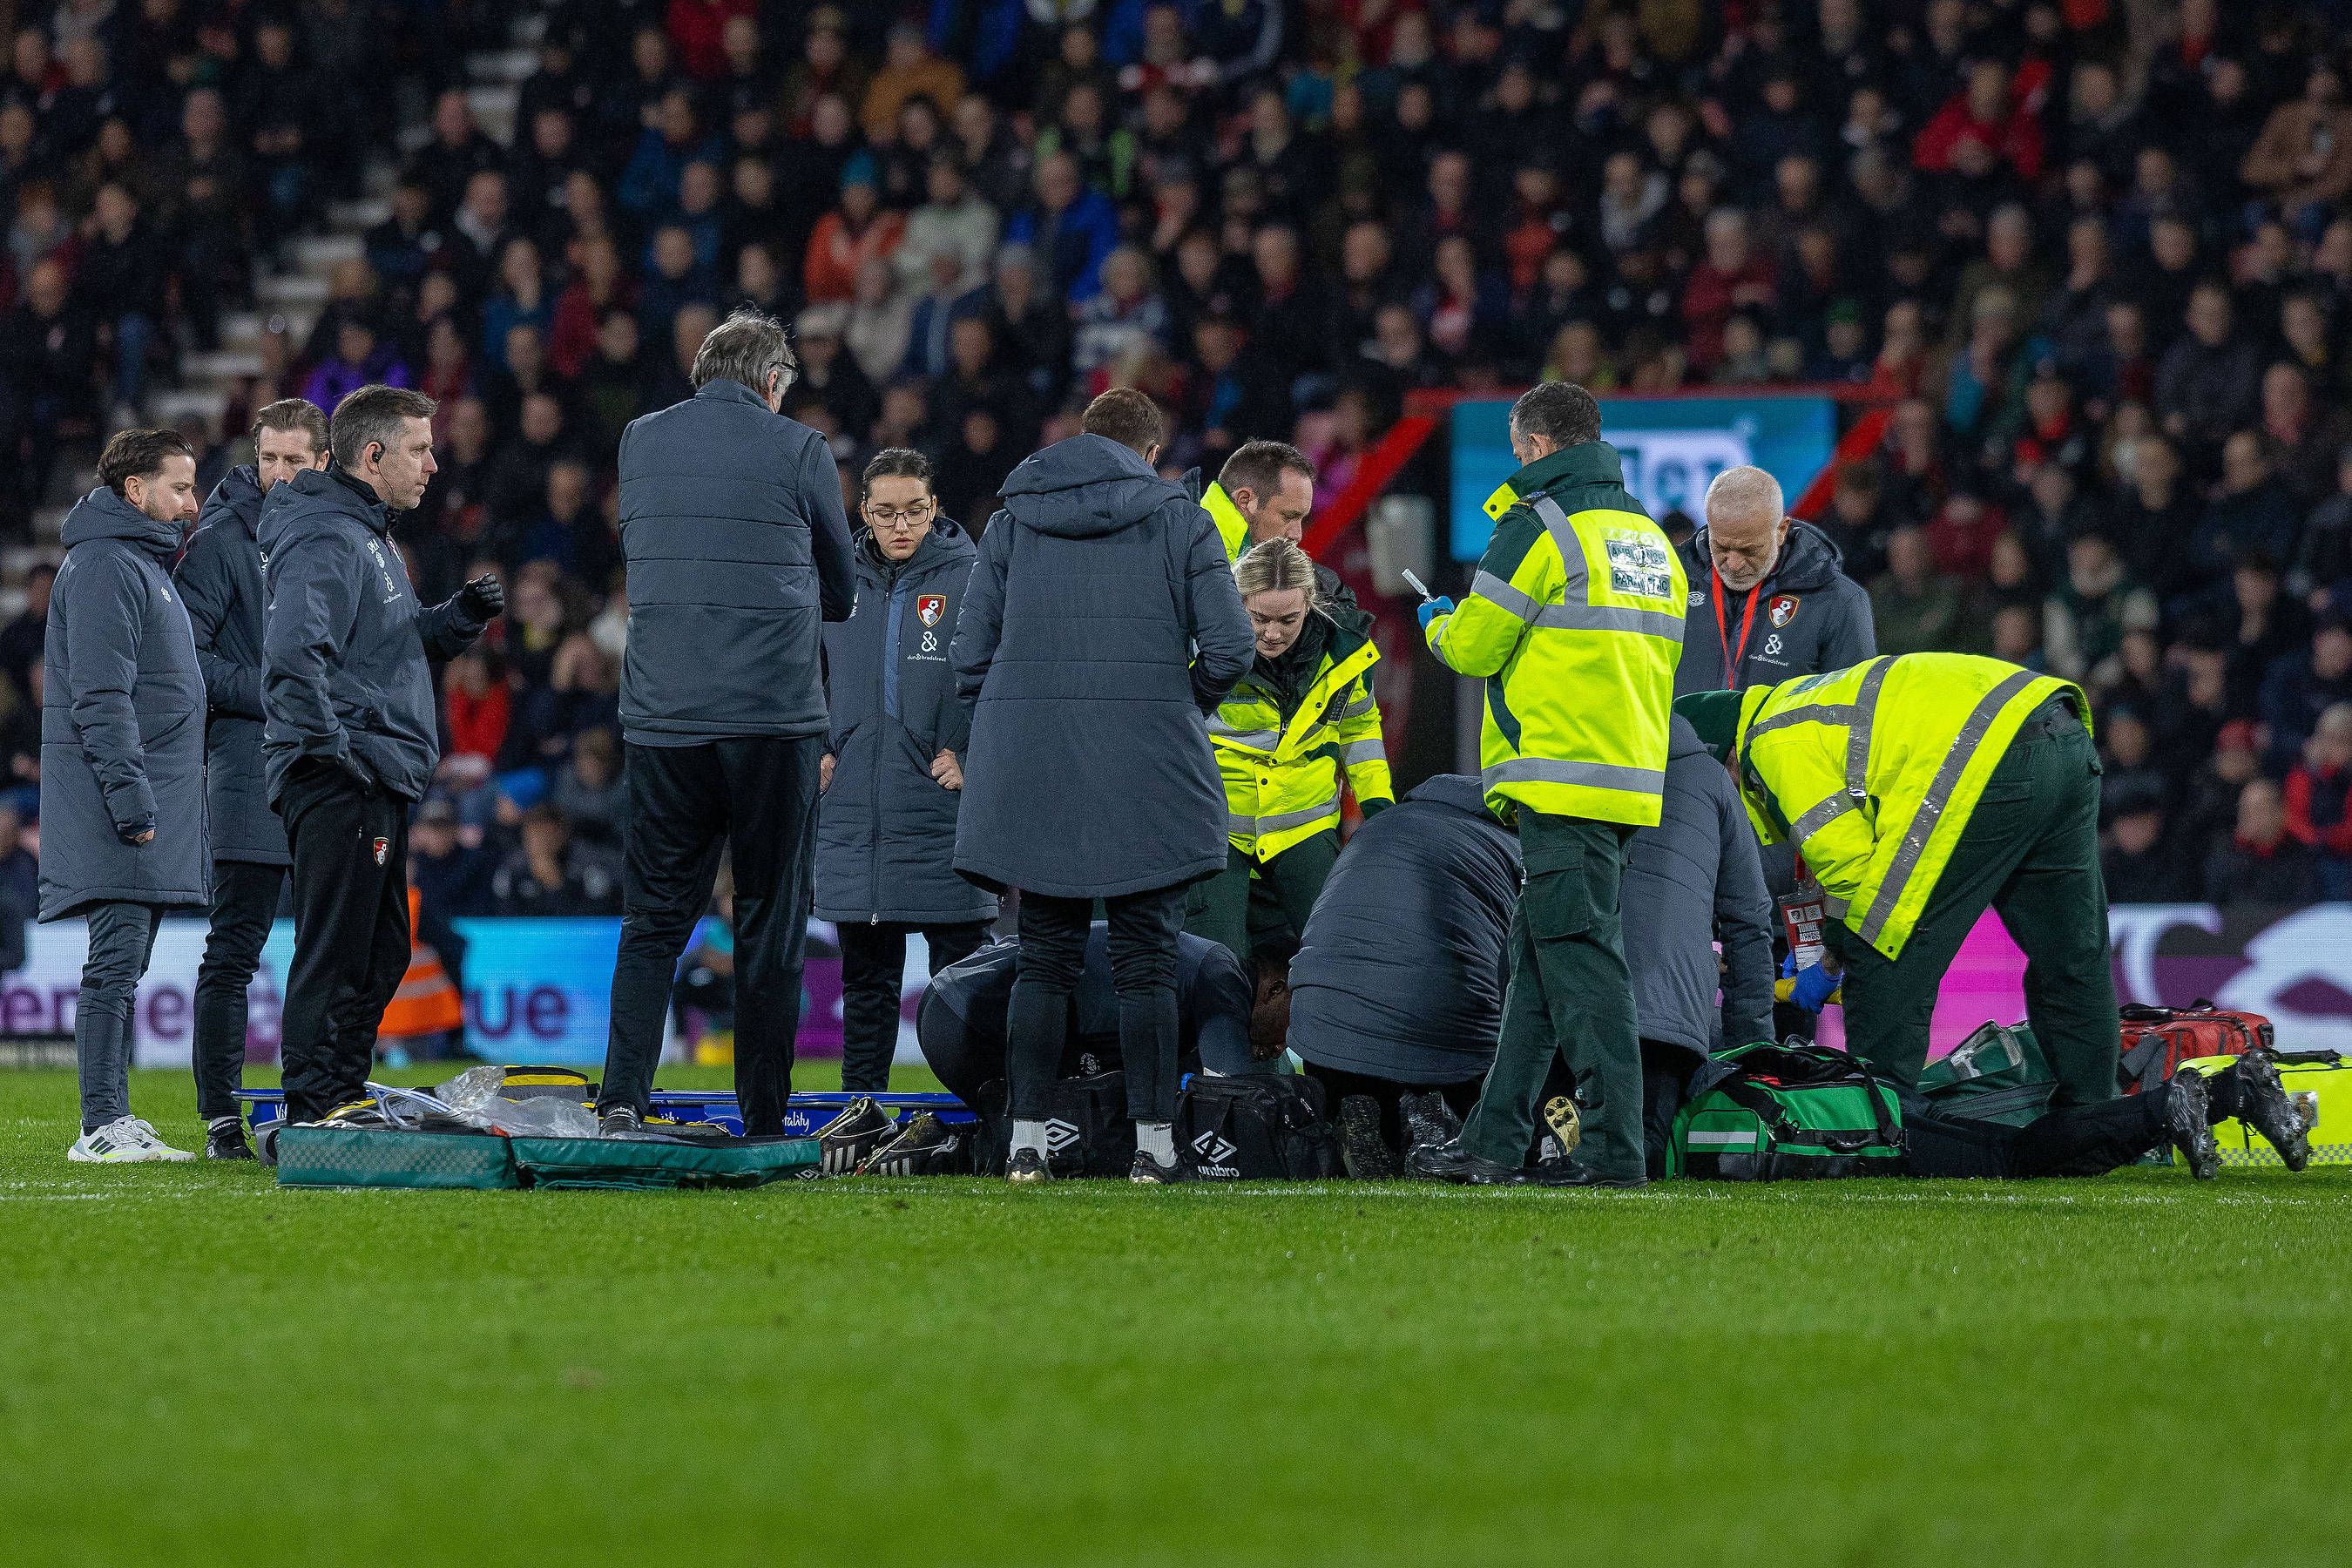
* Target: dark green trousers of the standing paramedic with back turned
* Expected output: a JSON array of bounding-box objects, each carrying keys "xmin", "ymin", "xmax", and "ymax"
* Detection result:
[{"xmin": 1463, "ymin": 822, "xmax": 1644, "ymax": 1180}]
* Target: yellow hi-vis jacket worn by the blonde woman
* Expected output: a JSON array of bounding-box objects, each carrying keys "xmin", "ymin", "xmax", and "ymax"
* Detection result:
[{"xmin": 1209, "ymin": 612, "xmax": 1395, "ymax": 861}]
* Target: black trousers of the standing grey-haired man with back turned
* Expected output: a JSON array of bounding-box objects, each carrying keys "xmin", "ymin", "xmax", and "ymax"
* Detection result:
[{"xmin": 600, "ymin": 736, "xmax": 823, "ymax": 1138}]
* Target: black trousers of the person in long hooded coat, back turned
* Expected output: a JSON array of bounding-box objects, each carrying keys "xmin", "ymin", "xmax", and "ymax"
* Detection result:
[{"xmin": 1004, "ymin": 886, "xmax": 1183, "ymax": 1121}]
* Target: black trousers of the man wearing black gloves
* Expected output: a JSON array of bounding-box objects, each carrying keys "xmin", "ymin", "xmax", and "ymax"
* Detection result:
[{"xmin": 278, "ymin": 761, "xmax": 409, "ymax": 1121}]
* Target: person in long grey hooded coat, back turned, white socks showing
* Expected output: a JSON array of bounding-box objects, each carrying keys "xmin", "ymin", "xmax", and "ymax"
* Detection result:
[{"xmin": 953, "ymin": 388, "xmax": 1256, "ymax": 1182}]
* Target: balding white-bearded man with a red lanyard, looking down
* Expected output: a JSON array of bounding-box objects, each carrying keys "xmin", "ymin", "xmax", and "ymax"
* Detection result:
[{"xmin": 1674, "ymin": 465, "xmax": 1879, "ymax": 696}]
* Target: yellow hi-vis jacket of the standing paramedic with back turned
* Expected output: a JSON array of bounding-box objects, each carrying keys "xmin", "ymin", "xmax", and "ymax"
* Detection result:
[{"xmin": 1428, "ymin": 442, "xmax": 1689, "ymax": 828}]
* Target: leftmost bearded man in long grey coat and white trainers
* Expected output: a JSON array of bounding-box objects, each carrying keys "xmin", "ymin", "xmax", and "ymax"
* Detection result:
[{"xmin": 40, "ymin": 430, "xmax": 212, "ymax": 1161}]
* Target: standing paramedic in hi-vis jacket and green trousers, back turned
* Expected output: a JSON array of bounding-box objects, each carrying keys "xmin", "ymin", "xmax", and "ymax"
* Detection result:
[{"xmin": 1411, "ymin": 381, "xmax": 1689, "ymax": 1187}]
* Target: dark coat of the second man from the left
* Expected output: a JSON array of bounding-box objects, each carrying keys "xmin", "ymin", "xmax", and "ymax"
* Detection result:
[{"xmin": 172, "ymin": 465, "xmax": 294, "ymax": 865}]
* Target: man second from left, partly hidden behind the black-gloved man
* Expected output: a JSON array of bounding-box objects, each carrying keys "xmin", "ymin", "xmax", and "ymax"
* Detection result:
[{"xmin": 174, "ymin": 397, "xmax": 327, "ymax": 1159}]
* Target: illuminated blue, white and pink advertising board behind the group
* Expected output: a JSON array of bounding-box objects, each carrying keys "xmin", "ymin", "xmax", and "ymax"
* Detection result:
[{"xmin": 0, "ymin": 902, "xmax": 2352, "ymax": 1067}]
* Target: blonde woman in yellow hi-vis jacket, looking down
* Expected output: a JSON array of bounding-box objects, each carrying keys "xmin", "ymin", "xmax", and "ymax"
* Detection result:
[{"xmin": 1186, "ymin": 538, "xmax": 1395, "ymax": 966}]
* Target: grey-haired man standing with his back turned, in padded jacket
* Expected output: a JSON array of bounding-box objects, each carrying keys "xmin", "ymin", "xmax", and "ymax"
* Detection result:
[{"xmin": 598, "ymin": 308, "xmax": 856, "ymax": 1135}]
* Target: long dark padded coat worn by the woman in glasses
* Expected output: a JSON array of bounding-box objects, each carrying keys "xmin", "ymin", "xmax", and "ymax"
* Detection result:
[{"xmin": 816, "ymin": 517, "xmax": 997, "ymax": 926}]
